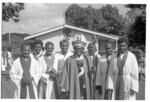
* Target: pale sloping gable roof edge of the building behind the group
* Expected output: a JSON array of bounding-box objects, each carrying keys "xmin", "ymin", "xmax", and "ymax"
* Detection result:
[{"xmin": 24, "ymin": 24, "xmax": 120, "ymax": 40}]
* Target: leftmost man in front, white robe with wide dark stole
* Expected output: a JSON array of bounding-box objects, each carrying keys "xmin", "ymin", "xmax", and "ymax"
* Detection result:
[{"xmin": 10, "ymin": 42, "xmax": 41, "ymax": 99}]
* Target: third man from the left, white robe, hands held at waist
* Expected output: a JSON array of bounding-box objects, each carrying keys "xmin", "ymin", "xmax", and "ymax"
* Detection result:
[{"xmin": 38, "ymin": 42, "xmax": 58, "ymax": 99}]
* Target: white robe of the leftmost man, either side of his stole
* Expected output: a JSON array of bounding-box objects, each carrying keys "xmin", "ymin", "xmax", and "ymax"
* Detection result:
[{"xmin": 10, "ymin": 58, "xmax": 41, "ymax": 98}]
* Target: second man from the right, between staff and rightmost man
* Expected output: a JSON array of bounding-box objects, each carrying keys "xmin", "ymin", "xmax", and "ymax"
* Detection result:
[{"xmin": 97, "ymin": 42, "xmax": 115, "ymax": 99}]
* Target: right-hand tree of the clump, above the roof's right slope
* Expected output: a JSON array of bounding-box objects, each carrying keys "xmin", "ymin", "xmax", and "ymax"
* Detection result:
[{"xmin": 101, "ymin": 5, "xmax": 124, "ymax": 35}]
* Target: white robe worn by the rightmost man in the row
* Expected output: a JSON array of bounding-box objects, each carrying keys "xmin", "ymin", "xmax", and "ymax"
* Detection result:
[{"xmin": 108, "ymin": 52, "xmax": 139, "ymax": 100}]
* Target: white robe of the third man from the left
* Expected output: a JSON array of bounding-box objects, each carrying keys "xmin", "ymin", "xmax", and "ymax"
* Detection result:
[{"xmin": 38, "ymin": 56, "xmax": 57, "ymax": 99}]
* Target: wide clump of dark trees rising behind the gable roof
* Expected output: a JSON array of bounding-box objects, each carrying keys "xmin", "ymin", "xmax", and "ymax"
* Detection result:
[{"xmin": 65, "ymin": 4, "xmax": 124, "ymax": 35}]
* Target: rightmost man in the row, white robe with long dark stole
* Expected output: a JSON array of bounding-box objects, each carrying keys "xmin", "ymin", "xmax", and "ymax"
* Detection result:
[{"xmin": 108, "ymin": 38, "xmax": 139, "ymax": 100}]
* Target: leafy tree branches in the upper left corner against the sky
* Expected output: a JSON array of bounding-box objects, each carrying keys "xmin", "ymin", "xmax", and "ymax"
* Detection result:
[{"xmin": 2, "ymin": 3, "xmax": 24, "ymax": 22}]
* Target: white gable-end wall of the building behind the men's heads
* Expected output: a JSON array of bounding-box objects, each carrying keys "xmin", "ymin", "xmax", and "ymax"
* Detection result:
[{"xmin": 36, "ymin": 29, "xmax": 116, "ymax": 53}]
